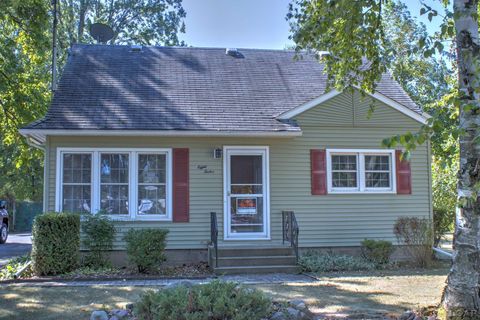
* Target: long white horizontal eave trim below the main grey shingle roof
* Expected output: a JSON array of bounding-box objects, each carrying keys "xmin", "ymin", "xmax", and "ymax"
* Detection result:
[{"xmin": 19, "ymin": 129, "xmax": 302, "ymax": 147}]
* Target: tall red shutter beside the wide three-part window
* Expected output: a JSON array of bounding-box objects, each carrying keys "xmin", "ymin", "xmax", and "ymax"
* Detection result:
[{"xmin": 173, "ymin": 148, "xmax": 190, "ymax": 222}]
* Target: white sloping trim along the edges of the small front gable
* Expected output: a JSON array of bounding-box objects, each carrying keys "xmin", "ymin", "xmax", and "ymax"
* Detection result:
[{"xmin": 277, "ymin": 86, "xmax": 430, "ymax": 124}]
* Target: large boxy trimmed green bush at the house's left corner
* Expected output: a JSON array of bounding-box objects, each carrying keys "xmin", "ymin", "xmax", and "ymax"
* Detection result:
[{"xmin": 32, "ymin": 213, "xmax": 80, "ymax": 276}]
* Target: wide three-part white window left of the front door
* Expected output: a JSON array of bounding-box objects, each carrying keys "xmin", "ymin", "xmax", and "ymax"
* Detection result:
[{"xmin": 56, "ymin": 148, "xmax": 172, "ymax": 220}]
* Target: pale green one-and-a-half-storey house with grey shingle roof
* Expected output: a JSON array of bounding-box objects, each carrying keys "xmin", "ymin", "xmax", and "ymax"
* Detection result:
[{"xmin": 20, "ymin": 45, "xmax": 432, "ymax": 271}]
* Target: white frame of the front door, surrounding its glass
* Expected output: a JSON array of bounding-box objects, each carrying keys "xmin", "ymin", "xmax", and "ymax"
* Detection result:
[{"xmin": 223, "ymin": 146, "xmax": 270, "ymax": 241}]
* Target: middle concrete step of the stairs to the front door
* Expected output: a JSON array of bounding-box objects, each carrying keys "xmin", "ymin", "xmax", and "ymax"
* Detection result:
[{"xmin": 214, "ymin": 255, "xmax": 296, "ymax": 267}]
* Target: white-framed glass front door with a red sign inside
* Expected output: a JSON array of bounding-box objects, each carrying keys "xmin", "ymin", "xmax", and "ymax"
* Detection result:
[{"xmin": 224, "ymin": 147, "xmax": 270, "ymax": 240}]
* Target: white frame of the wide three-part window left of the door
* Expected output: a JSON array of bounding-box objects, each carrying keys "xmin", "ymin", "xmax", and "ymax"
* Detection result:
[{"xmin": 55, "ymin": 147, "xmax": 173, "ymax": 221}]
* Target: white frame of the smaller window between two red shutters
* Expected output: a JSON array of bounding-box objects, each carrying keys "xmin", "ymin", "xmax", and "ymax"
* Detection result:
[{"xmin": 327, "ymin": 149, "xmax": 397, "ymax": 194}]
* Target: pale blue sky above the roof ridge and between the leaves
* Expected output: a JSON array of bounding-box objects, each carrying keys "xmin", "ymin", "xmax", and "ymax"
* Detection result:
[{"xmin": 181, "ymin": 0, "xmax": 448, "ymax": 49}]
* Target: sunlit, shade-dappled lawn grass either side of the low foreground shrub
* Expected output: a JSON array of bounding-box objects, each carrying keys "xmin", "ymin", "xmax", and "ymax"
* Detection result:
[{"xmin": 0, "ymin": 269, "xmax": 448, "ymax": 320}]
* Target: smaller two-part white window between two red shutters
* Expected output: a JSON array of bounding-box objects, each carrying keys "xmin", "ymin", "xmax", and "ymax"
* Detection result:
[{"xmin": 327, "ymin": 149, "xmax": 395, "ymax": 193}]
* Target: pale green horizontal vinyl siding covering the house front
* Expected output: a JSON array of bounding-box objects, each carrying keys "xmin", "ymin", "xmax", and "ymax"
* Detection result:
[{"xmin": 46, "ymin": 93, "xmax": 431, "ymax": 249}]
